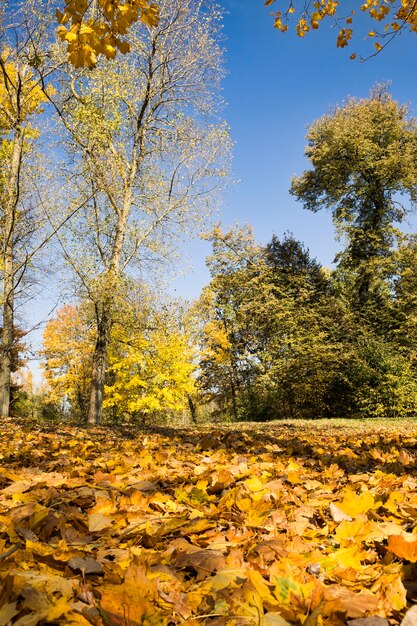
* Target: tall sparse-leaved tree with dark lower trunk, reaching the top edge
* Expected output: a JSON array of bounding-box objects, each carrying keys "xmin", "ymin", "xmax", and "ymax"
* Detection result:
[{"xmin": 55, "ymin": 0, "xmax": 230, "ymax": 423}]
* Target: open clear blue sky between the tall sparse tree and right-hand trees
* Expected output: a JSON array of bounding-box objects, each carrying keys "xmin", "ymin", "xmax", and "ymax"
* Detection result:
[{"xmin": 170, "ymin": 0, "xmax": 417, "ymax": 297}]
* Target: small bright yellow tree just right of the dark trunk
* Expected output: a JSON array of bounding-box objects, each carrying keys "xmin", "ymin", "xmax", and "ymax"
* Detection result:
[{"xmin": 104, "ymin": 303, "xmax": 195, "ymax": 419}]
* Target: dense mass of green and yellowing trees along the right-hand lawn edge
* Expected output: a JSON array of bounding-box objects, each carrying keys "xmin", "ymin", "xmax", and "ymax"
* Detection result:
[{"xmin": 198, "ymin": 218, "xmax": 417, "ymax": 421}]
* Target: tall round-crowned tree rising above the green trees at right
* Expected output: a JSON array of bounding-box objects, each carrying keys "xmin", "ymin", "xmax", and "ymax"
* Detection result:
[{"xmin": 291, "ymin": 85, "xmax": 417, "ymax": 310}]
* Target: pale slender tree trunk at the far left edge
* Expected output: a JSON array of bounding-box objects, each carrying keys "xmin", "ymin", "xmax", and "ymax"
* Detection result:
[{"xmin": 0, "ymin": 127, "xmax": 23, "ymax": 417}]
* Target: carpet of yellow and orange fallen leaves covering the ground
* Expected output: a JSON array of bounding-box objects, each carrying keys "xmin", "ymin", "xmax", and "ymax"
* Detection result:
[{"xmin": 0, "ymin": 420, "xmax": 417, "ymax": 626}]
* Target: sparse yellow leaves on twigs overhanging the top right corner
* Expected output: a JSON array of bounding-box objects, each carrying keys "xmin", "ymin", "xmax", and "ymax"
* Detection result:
[{"xmin": 265, "ymin": 0, "xmax": 417, "ymax": 54}]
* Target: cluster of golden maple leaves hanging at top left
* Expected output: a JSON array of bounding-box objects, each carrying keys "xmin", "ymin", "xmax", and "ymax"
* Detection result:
[{"xmin": 56, "ymin": 0, "xmax": 158, "ymax": 68}]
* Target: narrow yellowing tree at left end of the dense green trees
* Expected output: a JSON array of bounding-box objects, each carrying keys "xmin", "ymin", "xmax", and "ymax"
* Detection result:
[{"xmin": 195, "ymin": 226, "xmax": 261, "ymax": 420}]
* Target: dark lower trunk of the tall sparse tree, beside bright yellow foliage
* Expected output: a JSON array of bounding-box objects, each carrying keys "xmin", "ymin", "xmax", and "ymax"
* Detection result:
[{"xmin": 87, "ymin": 307, "xmax": 111, "ymax": 425}]
